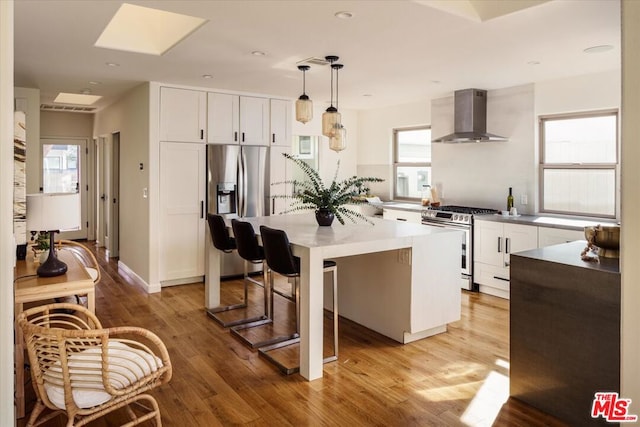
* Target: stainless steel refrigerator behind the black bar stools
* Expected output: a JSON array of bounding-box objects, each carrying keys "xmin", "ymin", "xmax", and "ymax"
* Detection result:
[{"xmin": 207, "ymin": 145, "xmax": 269, "ymax": 277}]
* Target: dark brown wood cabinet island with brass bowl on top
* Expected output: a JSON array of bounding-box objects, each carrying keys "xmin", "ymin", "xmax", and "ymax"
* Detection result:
[{"xmin": 509, "ymin": 241, "xmax": 620, "ymax": 426}]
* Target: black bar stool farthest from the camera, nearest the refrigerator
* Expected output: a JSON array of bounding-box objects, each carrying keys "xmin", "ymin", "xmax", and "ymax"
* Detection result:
[{"xmin": 207, "ymin": 214, "xmax": 266, "ymax": 328}]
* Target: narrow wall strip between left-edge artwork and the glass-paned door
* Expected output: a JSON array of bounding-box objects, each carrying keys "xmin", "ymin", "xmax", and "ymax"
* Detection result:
[{"xmin": 14, "ymin": 87, "xmax": 42, "ymax": 194}]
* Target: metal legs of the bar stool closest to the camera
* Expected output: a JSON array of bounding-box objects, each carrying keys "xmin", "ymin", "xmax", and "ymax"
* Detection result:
[{"xmin": 258, "ymin": 265, "xmax": 338, "ymax": 375}]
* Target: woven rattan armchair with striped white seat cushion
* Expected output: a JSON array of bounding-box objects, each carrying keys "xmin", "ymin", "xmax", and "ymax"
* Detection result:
[{"xmin": 16, "ymin": 303, "xmax": 172, "ymax": 427}]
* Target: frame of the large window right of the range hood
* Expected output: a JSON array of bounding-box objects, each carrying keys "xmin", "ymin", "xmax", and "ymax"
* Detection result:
[{"xmin": 538, "ymin": 109, "xmax": 620, "ymax": 219}]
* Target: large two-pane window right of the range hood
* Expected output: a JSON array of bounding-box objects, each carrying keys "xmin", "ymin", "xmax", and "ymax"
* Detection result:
[{"xmin": 540, "ymin": 111, "xmax": 618, "ymax": 218}]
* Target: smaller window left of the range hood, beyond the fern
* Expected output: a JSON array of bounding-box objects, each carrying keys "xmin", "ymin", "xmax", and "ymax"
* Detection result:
[{"xmin": 393, "ymin": 126, "xmax": 431, "ymax": 200}]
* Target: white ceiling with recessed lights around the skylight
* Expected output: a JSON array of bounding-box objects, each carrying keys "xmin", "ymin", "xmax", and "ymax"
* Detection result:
[{"xmin": 15, "ymin": 0, "xmax": 620, "ymax": 113}]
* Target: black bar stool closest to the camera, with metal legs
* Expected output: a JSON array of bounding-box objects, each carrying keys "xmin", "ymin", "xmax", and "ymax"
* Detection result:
[{"xmin": 258, "ymin": 225, "xmax": 338, "ymax": 375}]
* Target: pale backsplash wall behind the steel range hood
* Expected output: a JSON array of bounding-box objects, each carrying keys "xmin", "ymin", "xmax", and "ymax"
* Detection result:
[{"xmin": 431, "ymin": 85, "xmax": 535, "ymax": 213}]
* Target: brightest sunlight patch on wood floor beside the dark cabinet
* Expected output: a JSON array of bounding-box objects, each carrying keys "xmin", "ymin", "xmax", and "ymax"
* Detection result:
[{"xmin": 460, "ymin": 359, "xmax": 509, "ymax": 426}]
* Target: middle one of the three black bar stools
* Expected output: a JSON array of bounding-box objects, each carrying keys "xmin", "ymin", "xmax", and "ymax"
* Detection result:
[{"xmin": 231, "ymin": 219, "xmax": 292, "ymax": 348}]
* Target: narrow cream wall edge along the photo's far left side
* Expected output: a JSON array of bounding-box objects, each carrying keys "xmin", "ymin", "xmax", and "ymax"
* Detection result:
[{"xmin": 0, "ymin": 1, "xmax": 15, "ymax": 426}]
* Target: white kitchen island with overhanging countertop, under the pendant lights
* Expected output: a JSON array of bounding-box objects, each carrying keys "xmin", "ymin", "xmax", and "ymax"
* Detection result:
[{"xmin": 205, "ymin": 214, "xmax": 462, "ymax": 380}]
